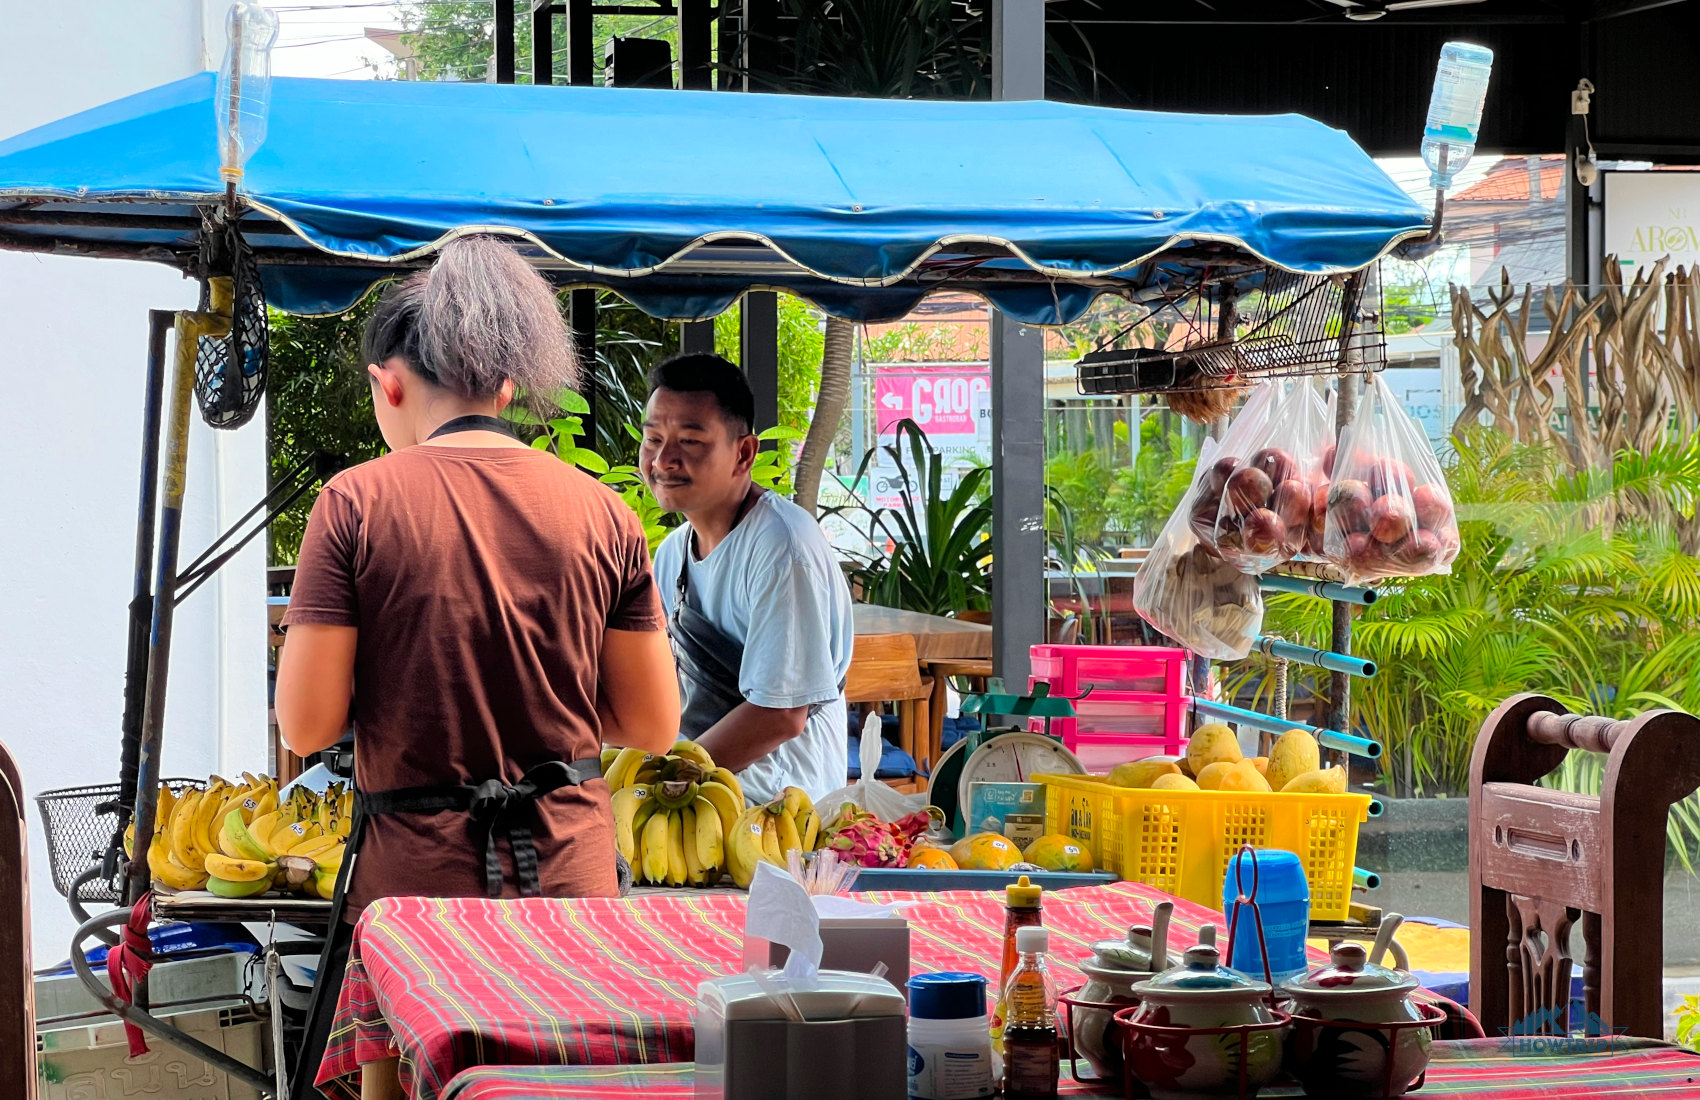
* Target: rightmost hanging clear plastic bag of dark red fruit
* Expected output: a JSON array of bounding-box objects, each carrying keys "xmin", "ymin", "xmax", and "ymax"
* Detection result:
[{"xmin": 1323, "ymin": 374, "xmax": 1459, "ymax": 585}]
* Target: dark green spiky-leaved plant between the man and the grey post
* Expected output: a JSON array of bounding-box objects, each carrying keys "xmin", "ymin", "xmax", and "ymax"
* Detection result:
[{"xmin": 823, "ymin": 420, "xmax": 991, "ymax": 615}]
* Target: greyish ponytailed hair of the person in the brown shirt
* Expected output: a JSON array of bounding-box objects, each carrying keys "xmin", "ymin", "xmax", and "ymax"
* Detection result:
[{"xmin": 362, "ymin": 236, "xmax": 578, "ymax": 403}]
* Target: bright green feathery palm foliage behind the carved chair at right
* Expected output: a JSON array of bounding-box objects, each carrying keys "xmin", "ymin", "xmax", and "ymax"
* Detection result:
[{"xmin": 1234, "ymin": 421, "xmax": 1700, "ymax": 809}]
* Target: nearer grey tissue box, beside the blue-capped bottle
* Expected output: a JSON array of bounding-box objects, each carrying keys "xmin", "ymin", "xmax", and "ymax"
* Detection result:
[{"xmin": 692, "ymin": 972, "xmax": 910, "ymax": 1100}]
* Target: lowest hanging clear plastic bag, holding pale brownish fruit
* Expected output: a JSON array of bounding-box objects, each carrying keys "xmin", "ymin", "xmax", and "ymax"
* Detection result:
[{"xmin": 1134, "ymin": 440, "xmax": 1263, "ymax": 661}]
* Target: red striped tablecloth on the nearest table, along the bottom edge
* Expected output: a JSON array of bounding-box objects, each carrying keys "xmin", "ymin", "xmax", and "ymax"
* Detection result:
[{"xmin": 442, "ymin": 1039, "xmax": 1700, "ymax": 1100}]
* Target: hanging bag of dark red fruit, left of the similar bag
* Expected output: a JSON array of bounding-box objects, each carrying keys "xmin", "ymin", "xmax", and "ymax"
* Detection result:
[{"xmin": 1188, "ymin": 379, "xmax": 1329, "ymax": 573}]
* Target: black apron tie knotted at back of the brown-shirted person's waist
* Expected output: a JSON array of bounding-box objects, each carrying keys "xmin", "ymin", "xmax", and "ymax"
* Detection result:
[{"xmin": 355, "ymin": 757, "xmax": 602, "ymax": 898}]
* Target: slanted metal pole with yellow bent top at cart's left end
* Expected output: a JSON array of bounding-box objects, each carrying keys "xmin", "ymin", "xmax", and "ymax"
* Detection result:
[{"xmin": 124, "ymin": 289, "xmax": 235, "ymax": 904}]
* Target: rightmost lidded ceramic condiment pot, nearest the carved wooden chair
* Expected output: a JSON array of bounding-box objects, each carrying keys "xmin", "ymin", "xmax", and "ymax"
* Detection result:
[{"xmin": 1284, "ymin": 944, "xmax": 1431, "ymax": 1098}]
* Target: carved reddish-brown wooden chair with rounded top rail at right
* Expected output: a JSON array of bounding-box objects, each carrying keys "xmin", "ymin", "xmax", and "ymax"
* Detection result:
[{"xmin": 1469, "ymin": 694, "xmax": 1700, "ymax": 1039}]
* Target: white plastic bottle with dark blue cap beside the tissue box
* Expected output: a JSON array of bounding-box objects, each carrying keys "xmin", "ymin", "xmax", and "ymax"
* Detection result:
[{"xmin": 910, "ymin": 972, "xmax": 998, "ymax": 1100}]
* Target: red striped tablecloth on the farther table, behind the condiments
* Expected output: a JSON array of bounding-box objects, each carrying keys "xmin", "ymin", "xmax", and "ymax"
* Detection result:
[{"xmin": 318, "ymin": 882, "xmax": 1221, "ymax": 1100}]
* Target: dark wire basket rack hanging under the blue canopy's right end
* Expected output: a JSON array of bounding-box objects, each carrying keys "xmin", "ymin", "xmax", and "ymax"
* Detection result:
[{"xmin": 1074, "ymin": 267, "xmax": 1387, "ymax": 396}]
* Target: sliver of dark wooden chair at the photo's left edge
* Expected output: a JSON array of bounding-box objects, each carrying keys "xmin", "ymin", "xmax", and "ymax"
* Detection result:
[{"xmin": 0, "ymin": 745, "xmax": 37, "ymax": 1100}]
